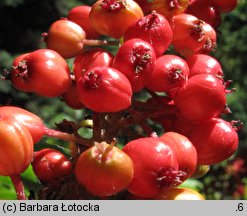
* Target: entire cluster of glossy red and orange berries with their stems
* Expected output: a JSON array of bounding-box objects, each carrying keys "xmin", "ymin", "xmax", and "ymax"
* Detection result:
[{"xmin": 0, "ymin": 0, "xmax": 238, "ymax": 199}]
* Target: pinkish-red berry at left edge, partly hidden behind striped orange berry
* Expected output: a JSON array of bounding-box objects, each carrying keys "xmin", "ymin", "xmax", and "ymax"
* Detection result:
[{"xmin": 0, "ymin": 106, "xmax": 44, "ymax": 143}]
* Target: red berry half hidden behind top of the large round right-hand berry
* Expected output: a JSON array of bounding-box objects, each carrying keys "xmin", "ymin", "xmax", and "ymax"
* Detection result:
[{"xmin": 186, "ymin": 54, "xmax": 224, "ymax": 78}]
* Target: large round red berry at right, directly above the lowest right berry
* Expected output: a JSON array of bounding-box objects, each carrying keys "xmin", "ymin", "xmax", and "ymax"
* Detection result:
[{"xmin": 174, "ymin": 74, "xmax": 226, "ymax": 121}]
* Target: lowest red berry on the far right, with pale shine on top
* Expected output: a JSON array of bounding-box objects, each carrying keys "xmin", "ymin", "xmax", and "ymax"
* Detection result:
[{"xmin": 189, "ymin": 118, "xmax": 238, "ymax": 165}]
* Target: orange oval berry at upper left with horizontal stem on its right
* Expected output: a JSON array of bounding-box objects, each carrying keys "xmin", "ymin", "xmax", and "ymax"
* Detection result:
[{"xmin": 44, "ymin": 19, "xmax": 86, "ymax": 58}]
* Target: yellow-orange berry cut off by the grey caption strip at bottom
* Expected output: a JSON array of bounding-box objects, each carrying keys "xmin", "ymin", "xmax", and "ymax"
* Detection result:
[{"xmin": 155, "ymin": 188, "xmax": 205, "ymax": 200}]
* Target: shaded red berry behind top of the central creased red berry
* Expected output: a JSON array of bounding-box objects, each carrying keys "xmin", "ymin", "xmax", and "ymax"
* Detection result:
[{"xmin": 73, "ymin": 48, "xmax": 114, "ymax": 82}]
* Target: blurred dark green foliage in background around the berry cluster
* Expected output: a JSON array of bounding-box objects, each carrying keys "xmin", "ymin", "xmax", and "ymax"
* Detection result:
[{"xmin": 0, "ymin": 0, "xmax": 247, "ymax": 199}]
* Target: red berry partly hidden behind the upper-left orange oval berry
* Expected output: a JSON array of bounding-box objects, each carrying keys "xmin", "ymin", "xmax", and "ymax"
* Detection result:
[{"xmin": 68, "ymin": 5, "xmax": 100, "ymax": 39}]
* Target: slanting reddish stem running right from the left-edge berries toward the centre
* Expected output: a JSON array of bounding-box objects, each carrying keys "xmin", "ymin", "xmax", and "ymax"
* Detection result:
[{"xmin": 44, "ymin": 127, "xmax": 92, "ymax": 147}]
